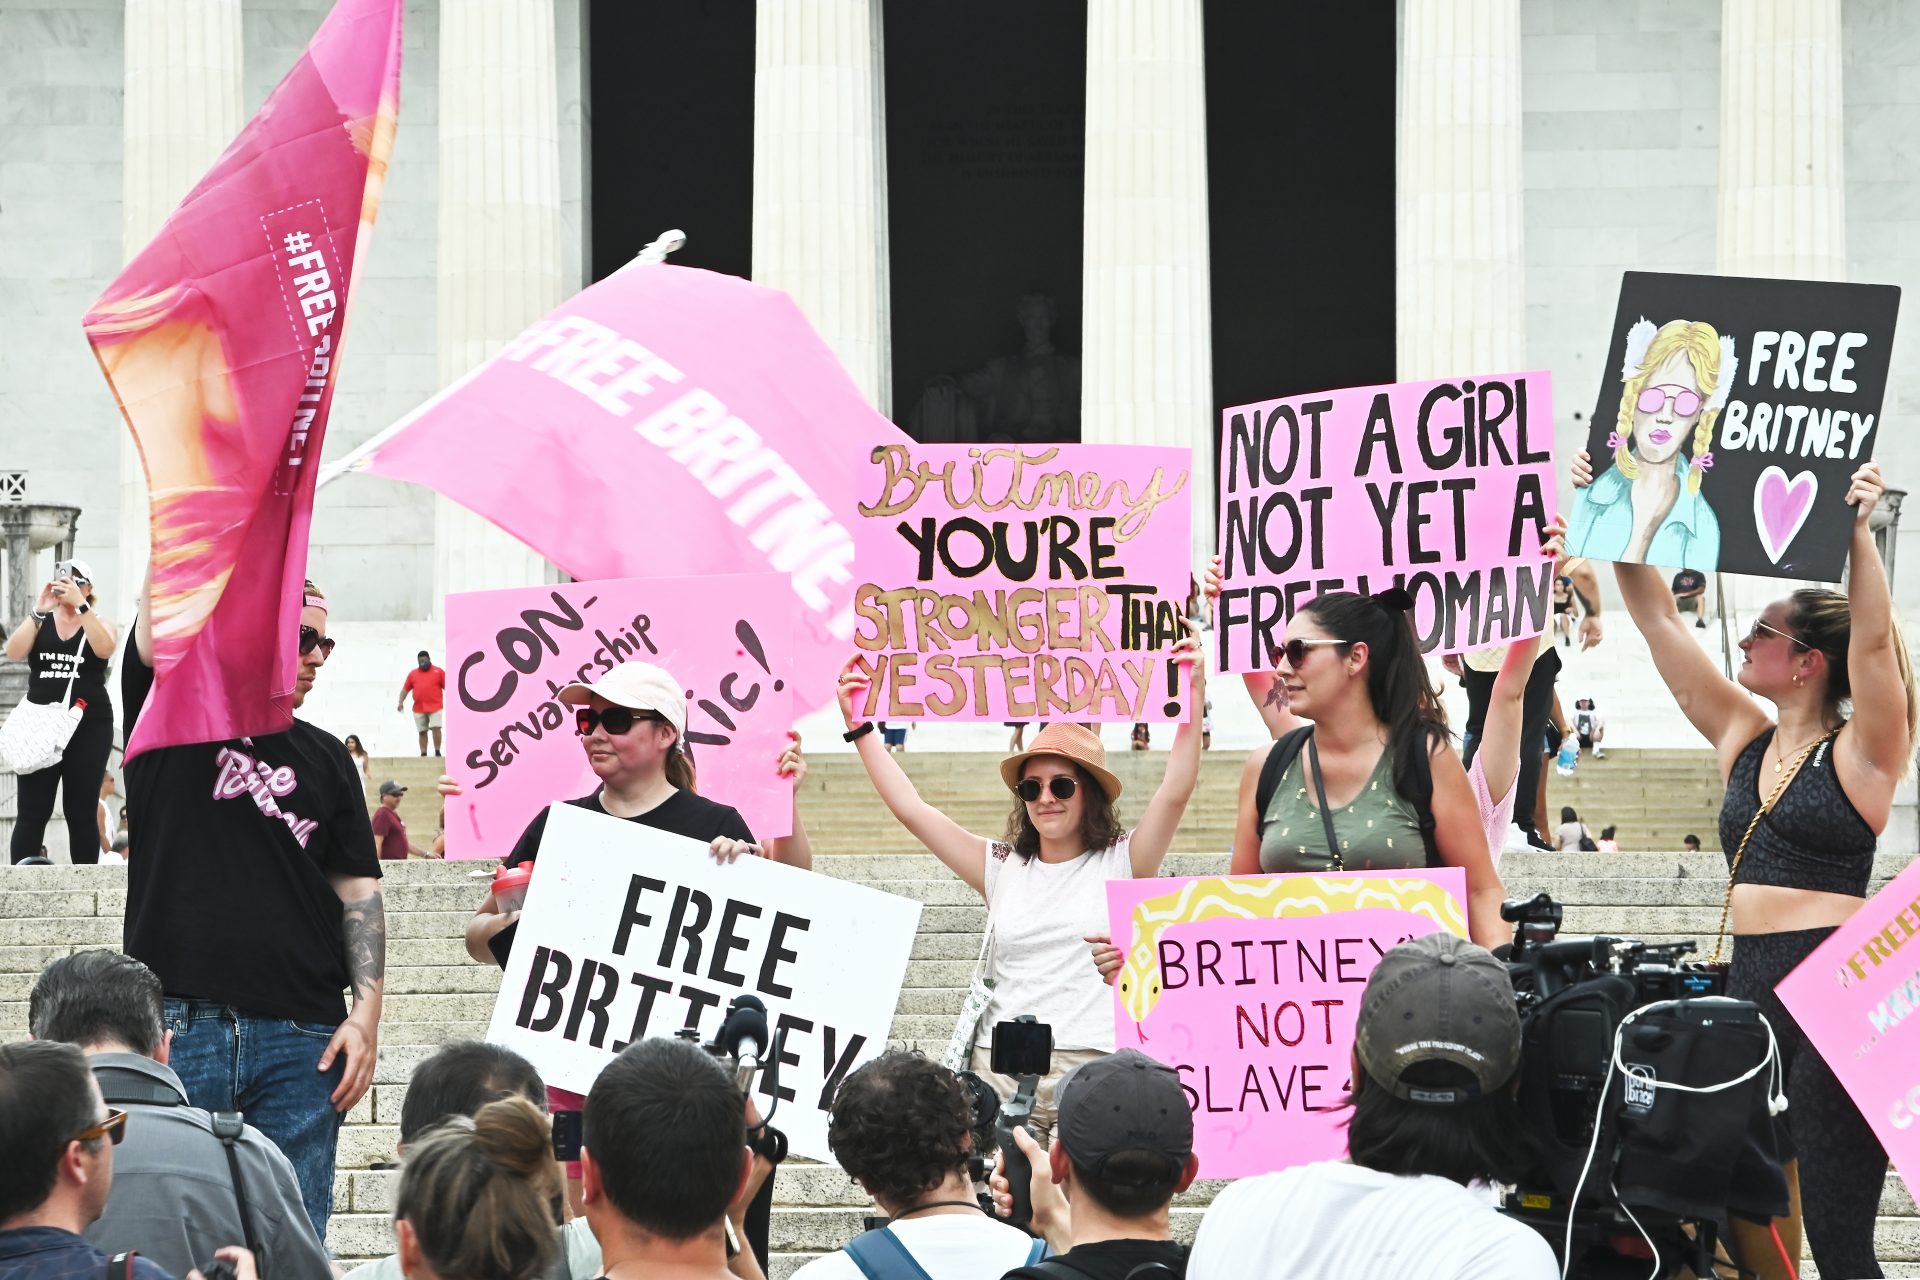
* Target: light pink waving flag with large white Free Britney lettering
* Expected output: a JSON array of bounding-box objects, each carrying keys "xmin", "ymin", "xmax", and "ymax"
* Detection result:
[{"xmin": 332, "ymin": 265, "xmax": 910, "ymax": 710}]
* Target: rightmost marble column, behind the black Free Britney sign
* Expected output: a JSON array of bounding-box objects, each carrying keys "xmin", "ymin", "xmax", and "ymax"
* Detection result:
[{"xmin": 1715, "ymin": 0, "xmax": 1847, "ymax": 624}]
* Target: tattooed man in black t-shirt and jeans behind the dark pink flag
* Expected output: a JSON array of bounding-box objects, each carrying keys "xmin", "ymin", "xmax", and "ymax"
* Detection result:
[{"xmin": 121, "ymin": 581, "xmax": 386, "ymax": 1242}]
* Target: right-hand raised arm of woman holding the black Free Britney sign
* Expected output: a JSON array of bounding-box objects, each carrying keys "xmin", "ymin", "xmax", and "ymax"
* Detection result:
[{"xmin": 1836, "ymin": 462, "xmax": 1912, "ymax": 812}]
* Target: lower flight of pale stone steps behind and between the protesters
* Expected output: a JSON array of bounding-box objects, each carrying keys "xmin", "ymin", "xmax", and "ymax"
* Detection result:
[{"xmin": 0, "ymin": 790, "xmax": 1920, "ymax": 1276}]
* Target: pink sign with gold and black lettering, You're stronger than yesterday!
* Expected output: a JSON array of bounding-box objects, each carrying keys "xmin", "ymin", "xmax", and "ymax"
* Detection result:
[{"xmin": 852, "ymin": 445, "xmax": 1192, "ymax": 723}]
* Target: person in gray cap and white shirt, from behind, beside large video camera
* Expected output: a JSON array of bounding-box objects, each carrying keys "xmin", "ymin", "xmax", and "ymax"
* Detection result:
[{"xmin": 1187, "ymin": 933, "xmax": 1559, "ymax": 1280}]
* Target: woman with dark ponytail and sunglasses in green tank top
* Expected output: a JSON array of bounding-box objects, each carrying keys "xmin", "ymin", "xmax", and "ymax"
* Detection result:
[{"xmin": 1233, "ymin": 589, "xmax": 1511, "ymax": 946}]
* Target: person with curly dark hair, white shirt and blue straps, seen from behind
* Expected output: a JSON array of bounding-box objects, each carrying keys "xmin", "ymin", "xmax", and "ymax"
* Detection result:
[{"xmin": 795, "ymin": 1050, "xmax": 1052, "ymax": 1280}]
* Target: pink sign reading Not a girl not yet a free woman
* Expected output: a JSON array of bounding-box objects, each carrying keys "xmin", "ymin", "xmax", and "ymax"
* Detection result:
[{"xmin": 1215, "ymin": 372, "xmax": 1553, "ymax": 672}]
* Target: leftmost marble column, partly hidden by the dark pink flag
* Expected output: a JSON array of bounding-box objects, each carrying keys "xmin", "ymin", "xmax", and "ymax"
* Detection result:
[{"xmin": 120, "ymin": 0, "xmax": 246, "ymax": 618}]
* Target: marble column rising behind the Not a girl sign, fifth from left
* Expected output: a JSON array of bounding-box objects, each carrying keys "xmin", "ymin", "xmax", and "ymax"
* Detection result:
[{"xmin": 1396, "ymin": 0, "xmax": 1526, "ymax": 380}]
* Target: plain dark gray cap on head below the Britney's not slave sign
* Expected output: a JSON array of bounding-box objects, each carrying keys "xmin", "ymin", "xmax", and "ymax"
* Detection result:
[{"xmin": 1054, "ymin": 1050, "xmax": 1194, "ymax": 1173}]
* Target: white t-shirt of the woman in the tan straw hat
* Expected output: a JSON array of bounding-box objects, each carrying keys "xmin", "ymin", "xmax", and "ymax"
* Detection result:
[{"xmin": 975, "ymin": 831, "xmax": 1133, "ymax": 1054}]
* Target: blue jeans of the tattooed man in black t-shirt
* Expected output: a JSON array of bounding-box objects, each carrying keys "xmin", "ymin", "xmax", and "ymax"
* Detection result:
[{"xmin": 167, "ymin": 996, "xmax": 346, "ymax": 1244}]
